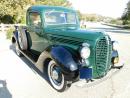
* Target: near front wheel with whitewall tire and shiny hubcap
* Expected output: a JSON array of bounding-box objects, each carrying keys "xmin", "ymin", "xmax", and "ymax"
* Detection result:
[{"xmin": 47, "ymin": 60, "xmax": 70, "ymax": 92}]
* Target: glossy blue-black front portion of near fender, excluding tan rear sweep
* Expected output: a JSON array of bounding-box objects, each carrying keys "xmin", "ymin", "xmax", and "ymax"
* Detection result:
[{"xmin": 50, "ymin": 46, "xmax": 79, "ymax": 80}]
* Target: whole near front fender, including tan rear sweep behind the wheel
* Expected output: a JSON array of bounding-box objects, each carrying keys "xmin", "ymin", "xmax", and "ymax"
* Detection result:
[{"xmin": 36, "ymin": 46, "xmax": 79, "ymax": 81}]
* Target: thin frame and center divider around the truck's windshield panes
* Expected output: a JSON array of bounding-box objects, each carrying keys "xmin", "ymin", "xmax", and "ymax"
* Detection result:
[{"xmin": 43, "ymin": 10, "xmax": 78, "ymax": 26}]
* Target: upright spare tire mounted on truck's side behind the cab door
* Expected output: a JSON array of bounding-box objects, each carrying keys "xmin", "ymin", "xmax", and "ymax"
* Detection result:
[{"xmin": 18, "ymin": 30, "xmax": 28, "ymax": 50}]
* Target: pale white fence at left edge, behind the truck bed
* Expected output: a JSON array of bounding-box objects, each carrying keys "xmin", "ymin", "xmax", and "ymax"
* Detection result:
[{"xmin": 0, "ymin": 24, "xmax": 25, "ymax": 32}]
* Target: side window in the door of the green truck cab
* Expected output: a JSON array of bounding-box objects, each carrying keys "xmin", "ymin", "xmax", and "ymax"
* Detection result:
[{"xmin": 29, "ymin": 12, "xmax": 41, "ymax": 26}]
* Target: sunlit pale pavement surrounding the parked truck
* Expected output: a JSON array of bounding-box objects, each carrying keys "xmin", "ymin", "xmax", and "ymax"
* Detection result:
[{"xmin": 0, "ymin": 23, "xmax": 130, "ymax": 98}]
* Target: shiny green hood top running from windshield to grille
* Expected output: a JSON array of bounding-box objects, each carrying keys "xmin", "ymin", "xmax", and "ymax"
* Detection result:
[{"xmin": 45, "ymin": 29, "xmax": 105, "ymax": 41}]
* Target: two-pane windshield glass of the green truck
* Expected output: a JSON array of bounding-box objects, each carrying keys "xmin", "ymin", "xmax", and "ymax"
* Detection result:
[{"xmin": 45, "ymin": 11, "xmax": 76, "ymax": 25}]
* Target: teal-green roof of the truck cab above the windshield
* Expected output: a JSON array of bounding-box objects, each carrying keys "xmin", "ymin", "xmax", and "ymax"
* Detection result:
[{"xmin": 28, "ymin": 5, "xmax": 75, "ymax": 12}]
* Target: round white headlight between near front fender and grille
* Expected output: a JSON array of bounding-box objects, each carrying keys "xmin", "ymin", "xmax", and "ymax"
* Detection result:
[{"xmin": 80, "ymin": 46, "xmax": 90, "ymax": 59}]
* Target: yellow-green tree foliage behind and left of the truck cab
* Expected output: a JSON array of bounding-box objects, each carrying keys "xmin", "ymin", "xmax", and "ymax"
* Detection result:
[{"xmin": 0, "ymin": 0, "xmax": 71, "ymax": 23}]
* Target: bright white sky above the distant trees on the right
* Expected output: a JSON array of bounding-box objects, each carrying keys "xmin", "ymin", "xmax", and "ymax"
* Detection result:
[{"xmin": 69, "ymin": 0, "xmax": 129, "ymax": 18}]
